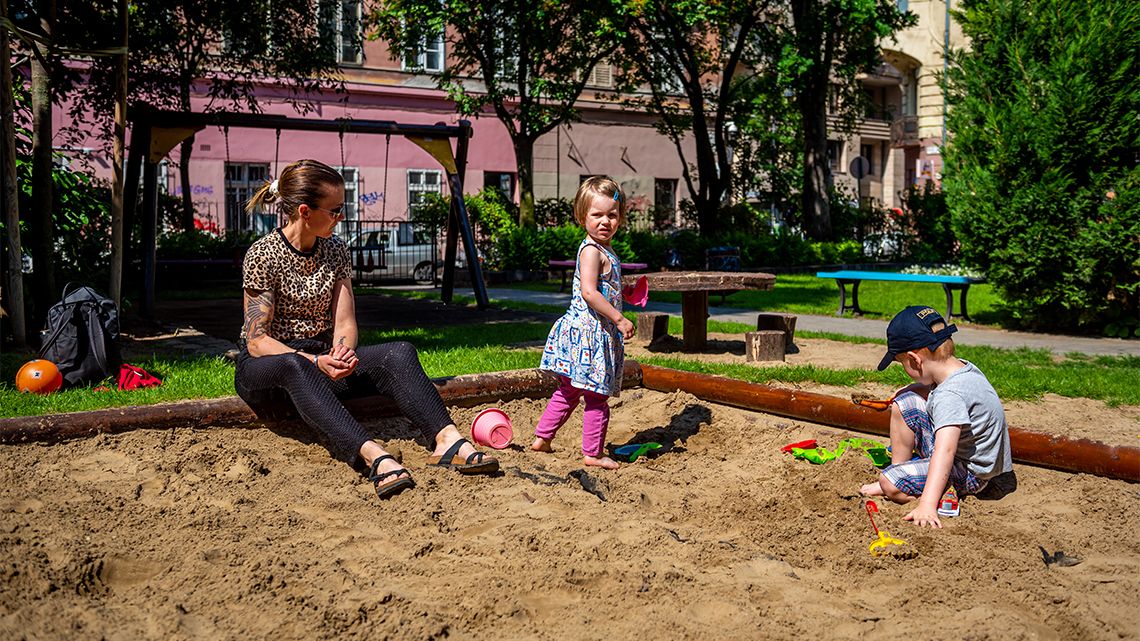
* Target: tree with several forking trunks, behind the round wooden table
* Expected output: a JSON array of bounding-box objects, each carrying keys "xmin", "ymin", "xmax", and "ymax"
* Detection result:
[{"xmin": 622, "ymin": 0, "xmax": 770, "ymax": 234}]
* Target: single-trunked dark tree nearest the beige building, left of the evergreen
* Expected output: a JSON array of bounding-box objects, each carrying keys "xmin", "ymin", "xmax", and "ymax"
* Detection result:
[{"xmin": 781, "ymin": 0, "xmax": 915, "ymax": 241}]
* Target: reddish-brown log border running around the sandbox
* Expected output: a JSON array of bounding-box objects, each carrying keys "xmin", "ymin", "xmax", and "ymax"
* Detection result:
[{"xmin": 0, "ymin": 359, "xmax": 1140, "ymax": 482}]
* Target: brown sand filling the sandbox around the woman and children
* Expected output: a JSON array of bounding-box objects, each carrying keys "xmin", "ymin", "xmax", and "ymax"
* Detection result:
[{"xmin": 0, "ymin": 330, "xmax": 1140, "ymax": 640}]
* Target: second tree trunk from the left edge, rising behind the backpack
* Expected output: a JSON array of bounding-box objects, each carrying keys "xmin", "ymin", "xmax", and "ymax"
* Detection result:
[{"xmin": 27, "ymin": 21, "xmax": 59, "ymax": 325}]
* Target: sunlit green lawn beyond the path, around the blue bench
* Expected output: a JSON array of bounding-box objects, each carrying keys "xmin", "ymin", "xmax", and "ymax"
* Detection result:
[{"xmin": 510, "ymin": 274, "xmax": 1001, "ymax": 325}]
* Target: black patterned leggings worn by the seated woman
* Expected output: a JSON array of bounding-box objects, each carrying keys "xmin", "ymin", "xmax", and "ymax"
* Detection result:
[{"xmin": 234, "ymin": 339, "xmax": 453, "ymax": 465}]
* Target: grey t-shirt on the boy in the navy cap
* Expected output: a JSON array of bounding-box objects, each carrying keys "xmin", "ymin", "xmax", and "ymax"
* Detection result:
[{"xmin": 927, "ymin": 360, "xmax": 1013, "ymax": 480}]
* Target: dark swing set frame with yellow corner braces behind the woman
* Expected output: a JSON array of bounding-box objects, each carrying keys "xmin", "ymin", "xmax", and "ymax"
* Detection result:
[{"xmin": 123, "ymin": 108, "xmax": 489, "ymax": 318}]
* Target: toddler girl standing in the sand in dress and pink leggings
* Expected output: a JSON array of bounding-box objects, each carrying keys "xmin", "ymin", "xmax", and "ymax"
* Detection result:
[{"xmin": 530, "ymin": 176, "xmax": 634, "ymax": 470}]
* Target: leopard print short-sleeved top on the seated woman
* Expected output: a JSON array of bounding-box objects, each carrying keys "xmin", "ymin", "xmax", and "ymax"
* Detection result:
[{"xmin": 242, "ymin": 227, "xmax": 352, "ymax": 342}]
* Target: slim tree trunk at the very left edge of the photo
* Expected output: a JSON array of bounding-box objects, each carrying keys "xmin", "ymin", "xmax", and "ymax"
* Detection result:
[{"xmin": 0, "ymin": 0, "xmax": 27, "ymax": 347}]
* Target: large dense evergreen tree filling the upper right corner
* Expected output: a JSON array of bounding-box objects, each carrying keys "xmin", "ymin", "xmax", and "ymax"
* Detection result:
[{"xmin": 943, "ymin": 0, "xmax": 1140, "ymax": 328}]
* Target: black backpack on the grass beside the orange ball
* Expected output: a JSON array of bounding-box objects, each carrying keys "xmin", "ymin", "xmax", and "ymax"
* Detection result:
[{"xmin": 40, "ymin": 283, "xmax": 121, "ymax": 387}]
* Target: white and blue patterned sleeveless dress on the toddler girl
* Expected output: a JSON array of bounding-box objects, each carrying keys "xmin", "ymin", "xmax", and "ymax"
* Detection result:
[{"xmin": 538, "ymin": 237, "xmax": 626, "ymax": 396}]
